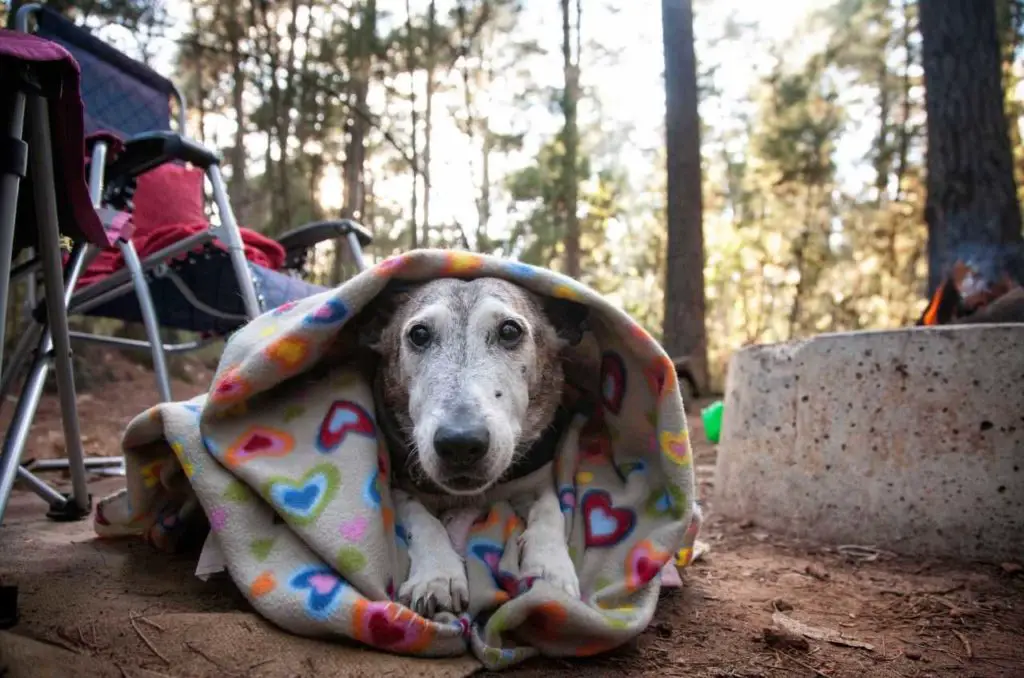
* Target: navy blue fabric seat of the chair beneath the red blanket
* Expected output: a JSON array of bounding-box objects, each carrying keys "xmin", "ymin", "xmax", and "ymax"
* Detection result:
[{"xmin": 88, "ymin": 246, "xmax": 326, "ymax": 335}]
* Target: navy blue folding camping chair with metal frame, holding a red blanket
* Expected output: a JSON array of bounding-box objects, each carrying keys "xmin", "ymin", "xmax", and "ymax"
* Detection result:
[{"xmin": 0, "ymin": 5, "xmax": 371, "ymax": 520}]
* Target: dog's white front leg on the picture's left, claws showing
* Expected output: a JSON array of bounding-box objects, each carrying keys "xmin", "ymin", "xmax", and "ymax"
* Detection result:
[{"xmin": 394, "ymin": 491, "xmax": 469, "ymax": 618}]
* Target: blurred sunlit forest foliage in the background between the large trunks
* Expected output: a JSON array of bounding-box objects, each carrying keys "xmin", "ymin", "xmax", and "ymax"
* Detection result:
[{"xmin": 18, "ymin": 0, "xmax": 1024, "ymax": 393}]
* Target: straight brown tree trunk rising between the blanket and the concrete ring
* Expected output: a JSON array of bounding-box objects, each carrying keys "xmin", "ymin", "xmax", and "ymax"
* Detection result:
[{"xmin": 662, "ymin": 0, "xmax": 708, "ymax": 388}]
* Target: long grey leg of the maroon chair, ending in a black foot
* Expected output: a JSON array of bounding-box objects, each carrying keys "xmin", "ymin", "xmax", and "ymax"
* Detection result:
[{"xmin": 29, "ymin": 96, "xmax": 92, "ymax": 518}]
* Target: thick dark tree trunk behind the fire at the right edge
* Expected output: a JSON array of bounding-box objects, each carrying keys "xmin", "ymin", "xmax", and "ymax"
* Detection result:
[{"xmin": 920, "ymin": 0, "xmax": 1024, "ymax": 295}]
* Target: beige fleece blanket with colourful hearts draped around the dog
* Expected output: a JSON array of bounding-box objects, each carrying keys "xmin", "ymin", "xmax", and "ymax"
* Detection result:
[{"xmin": 94, "ymin": 250, "xmax": 700, "ymax": 669}]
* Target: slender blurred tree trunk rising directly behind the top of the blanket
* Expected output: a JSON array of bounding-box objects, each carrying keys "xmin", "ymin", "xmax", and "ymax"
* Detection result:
[{"xmin": 561, "ymin": 0, "xmax": 580, "ymax": 278}]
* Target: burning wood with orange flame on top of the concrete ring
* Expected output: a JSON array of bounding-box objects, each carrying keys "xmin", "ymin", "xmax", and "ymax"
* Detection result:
[{"xmin": 918, "ymin": 246, "xmax": 1024, "ymax": 326}]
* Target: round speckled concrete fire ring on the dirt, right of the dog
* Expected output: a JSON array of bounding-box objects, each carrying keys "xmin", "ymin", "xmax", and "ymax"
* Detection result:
[{"xmin": 713, "ymin": 325, "xmax": 1024, "ymax": 562}]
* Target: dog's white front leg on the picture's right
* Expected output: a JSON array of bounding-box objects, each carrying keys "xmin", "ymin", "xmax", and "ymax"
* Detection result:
[{"xmin": 519, "ymin": 488, "xmax": 580, "ymax": 598}]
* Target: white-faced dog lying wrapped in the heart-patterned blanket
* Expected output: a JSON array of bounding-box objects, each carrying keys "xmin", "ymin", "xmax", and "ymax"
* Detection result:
[{"xmin": 357, "ymin": 278, "xmax": 587, "ymax": 618}]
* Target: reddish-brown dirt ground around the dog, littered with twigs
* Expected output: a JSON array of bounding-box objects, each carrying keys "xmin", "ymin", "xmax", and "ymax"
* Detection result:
[{"xmin": 0, "ymin": 357, "xmax": 1024, "ymax": 678}]
